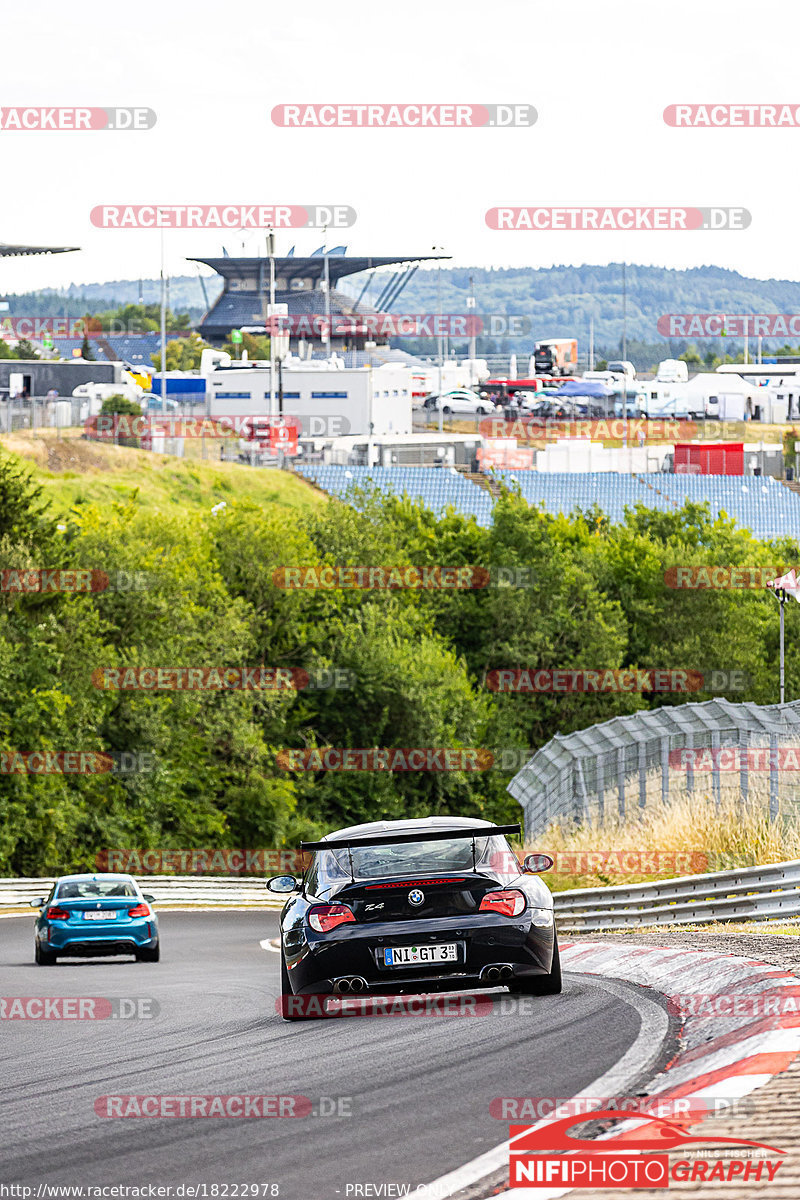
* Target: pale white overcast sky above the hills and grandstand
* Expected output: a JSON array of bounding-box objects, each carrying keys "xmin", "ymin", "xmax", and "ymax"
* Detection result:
[{"xmin": 0, "ymin": 0, "xmax": 800, "ymax": 295}]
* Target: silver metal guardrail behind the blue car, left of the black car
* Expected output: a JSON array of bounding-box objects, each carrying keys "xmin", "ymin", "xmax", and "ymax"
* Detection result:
[{"xmin": 0, "ymin": 875, "xmax": 285, "ymax": 908}]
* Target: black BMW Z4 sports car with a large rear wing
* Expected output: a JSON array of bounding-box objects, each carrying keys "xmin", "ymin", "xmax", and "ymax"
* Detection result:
[{"xmin": 266, "ymin": 817, "xmax": 561, "ymax": 1020}]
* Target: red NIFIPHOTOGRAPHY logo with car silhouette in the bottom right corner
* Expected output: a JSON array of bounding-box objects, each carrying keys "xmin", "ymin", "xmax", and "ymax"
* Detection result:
[{"xmin": 509, "ymin": 1109, "xmax": 786, "ymax": 1188}]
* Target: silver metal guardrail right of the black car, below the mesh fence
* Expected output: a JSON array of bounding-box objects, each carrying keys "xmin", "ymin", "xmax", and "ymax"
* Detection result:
[{"xmin": 553, "ymin": 859, "xmax": 800, "ymax": 934}]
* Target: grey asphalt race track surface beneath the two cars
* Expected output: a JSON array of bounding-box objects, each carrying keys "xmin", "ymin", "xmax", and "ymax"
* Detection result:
[{"xmin": 0, "ymin": 911, "xmax": 671, "ymax": 1200}]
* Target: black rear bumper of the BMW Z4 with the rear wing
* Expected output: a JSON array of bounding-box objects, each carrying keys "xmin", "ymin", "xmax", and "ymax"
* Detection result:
[{"xmin": 283, "ymin": 913, "xmax": 554, "ymax": 995}]
